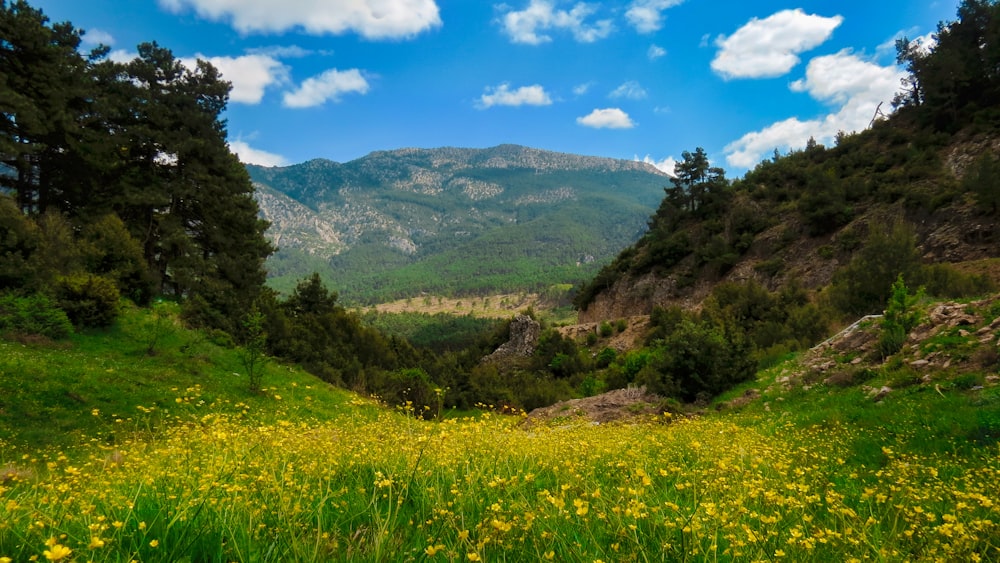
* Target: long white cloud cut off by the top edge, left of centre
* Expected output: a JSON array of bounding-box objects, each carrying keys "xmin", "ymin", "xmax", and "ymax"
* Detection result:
[{"xmin": 159, "ymin": 0, "xmax": 441, "ymax": 39}]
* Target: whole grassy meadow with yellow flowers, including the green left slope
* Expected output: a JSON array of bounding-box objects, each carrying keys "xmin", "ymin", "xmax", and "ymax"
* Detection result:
[{"xmin": 0, "ymin": 305, "xmax": 1000, "ymax": 562}]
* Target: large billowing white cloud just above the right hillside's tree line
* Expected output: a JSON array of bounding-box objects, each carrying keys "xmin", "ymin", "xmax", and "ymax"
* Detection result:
[{"xmin": 724, "ymin": 50, "xmax": 905, "ymax": 168}]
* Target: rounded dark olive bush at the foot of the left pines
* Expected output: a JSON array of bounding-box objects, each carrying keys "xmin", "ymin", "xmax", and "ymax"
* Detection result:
[{"xmin": 55, "ymin": 274, "xmax": 121, "ymax": 327}]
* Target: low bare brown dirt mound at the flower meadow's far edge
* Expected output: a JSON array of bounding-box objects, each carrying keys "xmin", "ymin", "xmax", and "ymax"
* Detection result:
[{"xmin": 528, "ymin": 387, "xmax": 663, "ymax": 423}]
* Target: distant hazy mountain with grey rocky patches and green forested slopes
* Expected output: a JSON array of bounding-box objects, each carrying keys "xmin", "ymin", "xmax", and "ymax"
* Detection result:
[{"xmin": 247, "ymin": 145, "xmax": 669, "ymax": 302}]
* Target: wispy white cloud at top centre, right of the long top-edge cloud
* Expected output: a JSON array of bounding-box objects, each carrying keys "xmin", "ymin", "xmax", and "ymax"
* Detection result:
[{"xmin": 501, "ymin": 0, "xmax": 614, "ymax": 45}]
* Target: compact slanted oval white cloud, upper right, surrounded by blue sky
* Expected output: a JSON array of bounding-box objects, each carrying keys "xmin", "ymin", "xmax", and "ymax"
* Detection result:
[{"xmin": 712, "ymin": 9, "xmax": 844, "ymax": 79}]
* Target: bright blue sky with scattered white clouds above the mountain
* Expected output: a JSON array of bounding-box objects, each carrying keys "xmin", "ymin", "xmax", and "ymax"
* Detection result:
[{"xmin": 29, "ymin": 0, "xmax": 958, "ymax": 176}]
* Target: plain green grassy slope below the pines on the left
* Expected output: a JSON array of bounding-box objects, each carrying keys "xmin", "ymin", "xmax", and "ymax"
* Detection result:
[{"xmin": 0, "ymin": 304, "xmax": 374, "ymax": 447}]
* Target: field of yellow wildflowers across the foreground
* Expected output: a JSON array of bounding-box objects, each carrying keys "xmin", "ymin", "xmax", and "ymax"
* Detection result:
[{"xmin": 0, "ymin": 388, "xmax": 1000, "ymax": 562}]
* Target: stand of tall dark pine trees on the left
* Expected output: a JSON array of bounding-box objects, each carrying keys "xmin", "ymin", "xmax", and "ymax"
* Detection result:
[{"xmin": 0, "ymin": 2, "xmax": 273, "ymax": 334}]
